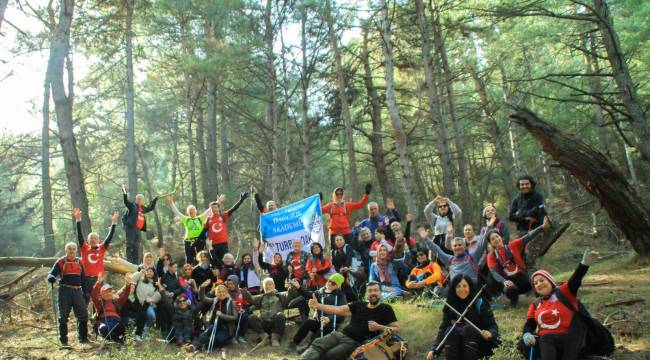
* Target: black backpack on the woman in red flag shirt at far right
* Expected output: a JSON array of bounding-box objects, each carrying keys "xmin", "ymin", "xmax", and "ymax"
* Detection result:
[{"xmin": 535, "ymin": 289, "xmax": 616, "ymax": 356}]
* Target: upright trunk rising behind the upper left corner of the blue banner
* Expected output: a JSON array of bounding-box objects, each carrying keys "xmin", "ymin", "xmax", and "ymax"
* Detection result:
[{"xmin": 264, "ymin": 0, "xmax": 280, "ymax": 200}]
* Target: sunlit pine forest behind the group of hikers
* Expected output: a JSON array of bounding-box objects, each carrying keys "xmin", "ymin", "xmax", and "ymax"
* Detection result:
[{"xmin": 0, "ymin": 0, "xmax": 650, "ymax": 359}]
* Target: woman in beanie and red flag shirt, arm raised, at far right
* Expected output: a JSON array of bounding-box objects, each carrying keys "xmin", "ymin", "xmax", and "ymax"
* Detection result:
[{"xmin": 522, "ymin": 250, "xmax": 600, "ymax": 360}]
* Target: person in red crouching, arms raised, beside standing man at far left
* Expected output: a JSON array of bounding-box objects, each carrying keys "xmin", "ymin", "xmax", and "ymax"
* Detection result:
[{"xmin": 91, "ymin": 273, "xmax": 133, "ymax": 343}]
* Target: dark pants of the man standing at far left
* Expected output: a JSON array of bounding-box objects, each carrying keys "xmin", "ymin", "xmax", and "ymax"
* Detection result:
[{"xmin": 59, "ymin": 285, "xmax": 88, "ymax": 344}]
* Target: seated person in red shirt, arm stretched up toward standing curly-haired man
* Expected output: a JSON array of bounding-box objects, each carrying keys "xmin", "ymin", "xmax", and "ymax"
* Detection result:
[{"xmin": 486, "ymin": 217, "xmax": 551, "ymax": 307}]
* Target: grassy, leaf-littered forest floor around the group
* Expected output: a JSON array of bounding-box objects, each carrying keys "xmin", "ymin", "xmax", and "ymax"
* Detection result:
[{"xmin": 0, "ymin": 226, "xmax": 650, "ymax": 360}]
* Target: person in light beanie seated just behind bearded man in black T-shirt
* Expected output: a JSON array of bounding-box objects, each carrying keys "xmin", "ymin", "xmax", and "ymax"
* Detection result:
[{"xmin": 286, "ymin": 273, "xmax": 348, "ymax": 354}]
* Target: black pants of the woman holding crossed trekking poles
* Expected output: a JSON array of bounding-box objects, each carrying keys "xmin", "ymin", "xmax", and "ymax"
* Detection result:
[{"xmin": 443, "ymin": 326, "xmax": 490, "ymax": 360}]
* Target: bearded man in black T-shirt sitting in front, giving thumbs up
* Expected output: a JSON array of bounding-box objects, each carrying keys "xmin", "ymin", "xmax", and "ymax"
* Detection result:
[{"xmin": 300, "ymin": 281, "xmax": 399, "ymax": 360}]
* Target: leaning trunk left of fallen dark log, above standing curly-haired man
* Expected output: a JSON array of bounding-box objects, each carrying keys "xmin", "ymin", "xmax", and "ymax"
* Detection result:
[{"xmin": 468, "ymin": 54, "xmax": 516, "ymax": 199}]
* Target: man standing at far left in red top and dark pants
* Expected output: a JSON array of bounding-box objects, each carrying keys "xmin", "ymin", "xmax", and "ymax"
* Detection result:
[{"xmin": 47, "ymin": 242, "xmax": 88, "ymax": 346}]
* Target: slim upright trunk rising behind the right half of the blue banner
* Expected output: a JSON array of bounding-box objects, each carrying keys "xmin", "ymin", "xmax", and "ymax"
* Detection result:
[{"xmin": 300, "ymin": 6, "xmax": 311, "ymax": 196}]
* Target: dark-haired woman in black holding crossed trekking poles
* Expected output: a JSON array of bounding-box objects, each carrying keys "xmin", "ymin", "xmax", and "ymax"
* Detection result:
[{"xmin": 427, "ymin": 274, "xmax": 499, "ymax": 360}]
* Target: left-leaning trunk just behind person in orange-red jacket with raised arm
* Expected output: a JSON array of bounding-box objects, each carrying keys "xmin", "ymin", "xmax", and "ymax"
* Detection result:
[{"xmin": 325, "ymin": 0, "xmax": 359, "ymax": 198}]
